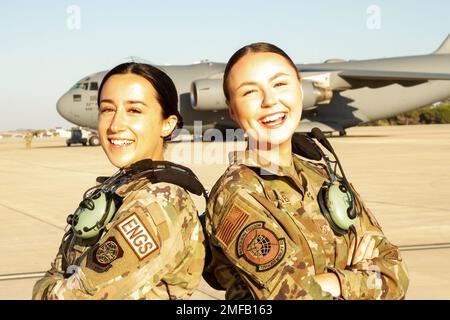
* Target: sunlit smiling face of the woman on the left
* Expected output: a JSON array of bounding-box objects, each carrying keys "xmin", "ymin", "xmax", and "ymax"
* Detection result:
[{"xmin": 98, "ymin": 74, "xmax": 176, "ymax": 168}]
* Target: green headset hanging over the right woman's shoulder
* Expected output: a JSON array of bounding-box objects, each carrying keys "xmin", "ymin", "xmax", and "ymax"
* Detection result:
[{"xmin": 292, "ymin": 128, "xmax": 358, "ymax": 236}]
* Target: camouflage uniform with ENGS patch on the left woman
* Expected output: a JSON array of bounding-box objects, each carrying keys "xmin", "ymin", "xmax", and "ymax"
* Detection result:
[{"xmin": 33, "ymin": 178, "xmax": 205, "ymax": 299}]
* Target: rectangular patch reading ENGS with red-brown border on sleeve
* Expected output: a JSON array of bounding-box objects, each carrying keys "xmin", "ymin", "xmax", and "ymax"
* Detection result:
[{"xmin": 116, "ymin": 213, "xmax": 159, "ymax": 260}]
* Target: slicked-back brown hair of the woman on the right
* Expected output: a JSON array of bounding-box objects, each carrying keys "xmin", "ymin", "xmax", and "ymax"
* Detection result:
[{"xmin": 223, "ymin": 42, "xmax": 300, "ymax": 100}]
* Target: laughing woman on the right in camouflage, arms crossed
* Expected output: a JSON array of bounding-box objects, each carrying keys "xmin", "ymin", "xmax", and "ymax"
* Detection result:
[{"xmin": 204, "ymin": 43, "xmax": 409, "ymax": 299}]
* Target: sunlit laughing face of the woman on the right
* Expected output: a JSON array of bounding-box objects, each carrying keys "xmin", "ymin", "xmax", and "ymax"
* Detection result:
[{"xmin": 228, "ymin": 52, "xmax": 303, "ymax": 145}]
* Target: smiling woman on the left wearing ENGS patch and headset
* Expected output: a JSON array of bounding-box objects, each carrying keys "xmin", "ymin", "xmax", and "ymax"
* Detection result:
[{"xmin": 33, "ymin": 63, "xmax": 205, "ymax": 299}]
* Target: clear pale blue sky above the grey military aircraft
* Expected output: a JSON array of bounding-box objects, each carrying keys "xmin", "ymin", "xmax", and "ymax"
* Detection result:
[{"xmin": 0, "ymin": 0, "xmax": 450, "ymax": 130}]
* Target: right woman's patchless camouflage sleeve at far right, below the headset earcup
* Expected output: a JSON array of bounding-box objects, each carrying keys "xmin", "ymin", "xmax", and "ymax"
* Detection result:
[{"xmin": 330, "ymin": 188, "xmax": 409, "ymax": 299}]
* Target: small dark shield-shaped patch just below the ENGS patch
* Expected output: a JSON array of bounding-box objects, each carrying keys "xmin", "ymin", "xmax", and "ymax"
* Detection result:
[{"xmin": 86, "ymin": 237, "xmax": 123, "ymax": 272}]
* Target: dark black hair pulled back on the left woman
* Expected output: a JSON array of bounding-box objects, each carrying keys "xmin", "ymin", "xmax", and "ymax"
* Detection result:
[{"xmin": 97, "ymin": 62, "xmax": 183, "ymax": 128}]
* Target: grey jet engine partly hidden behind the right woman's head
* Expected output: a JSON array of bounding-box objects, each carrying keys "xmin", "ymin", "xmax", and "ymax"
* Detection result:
[{"xmin": 191, "ymin": 79, "xmax": 333, "ymax": 111}]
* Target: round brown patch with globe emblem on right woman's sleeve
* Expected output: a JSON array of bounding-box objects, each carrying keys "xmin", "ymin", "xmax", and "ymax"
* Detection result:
[{"xmin": 236, "ymin": 221, "xmax": 286, "ymax": 271}]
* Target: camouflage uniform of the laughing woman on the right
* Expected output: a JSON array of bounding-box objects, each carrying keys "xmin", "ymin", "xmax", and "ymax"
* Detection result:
[{"xmin": 204, "ymin": 151, "xmax": 409, "ymax": 299}]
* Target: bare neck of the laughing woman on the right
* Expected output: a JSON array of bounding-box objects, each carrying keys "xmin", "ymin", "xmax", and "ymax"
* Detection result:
[{"xmin": 247, "ymin": 139, "xmax": 292, "ymax": 167}]
